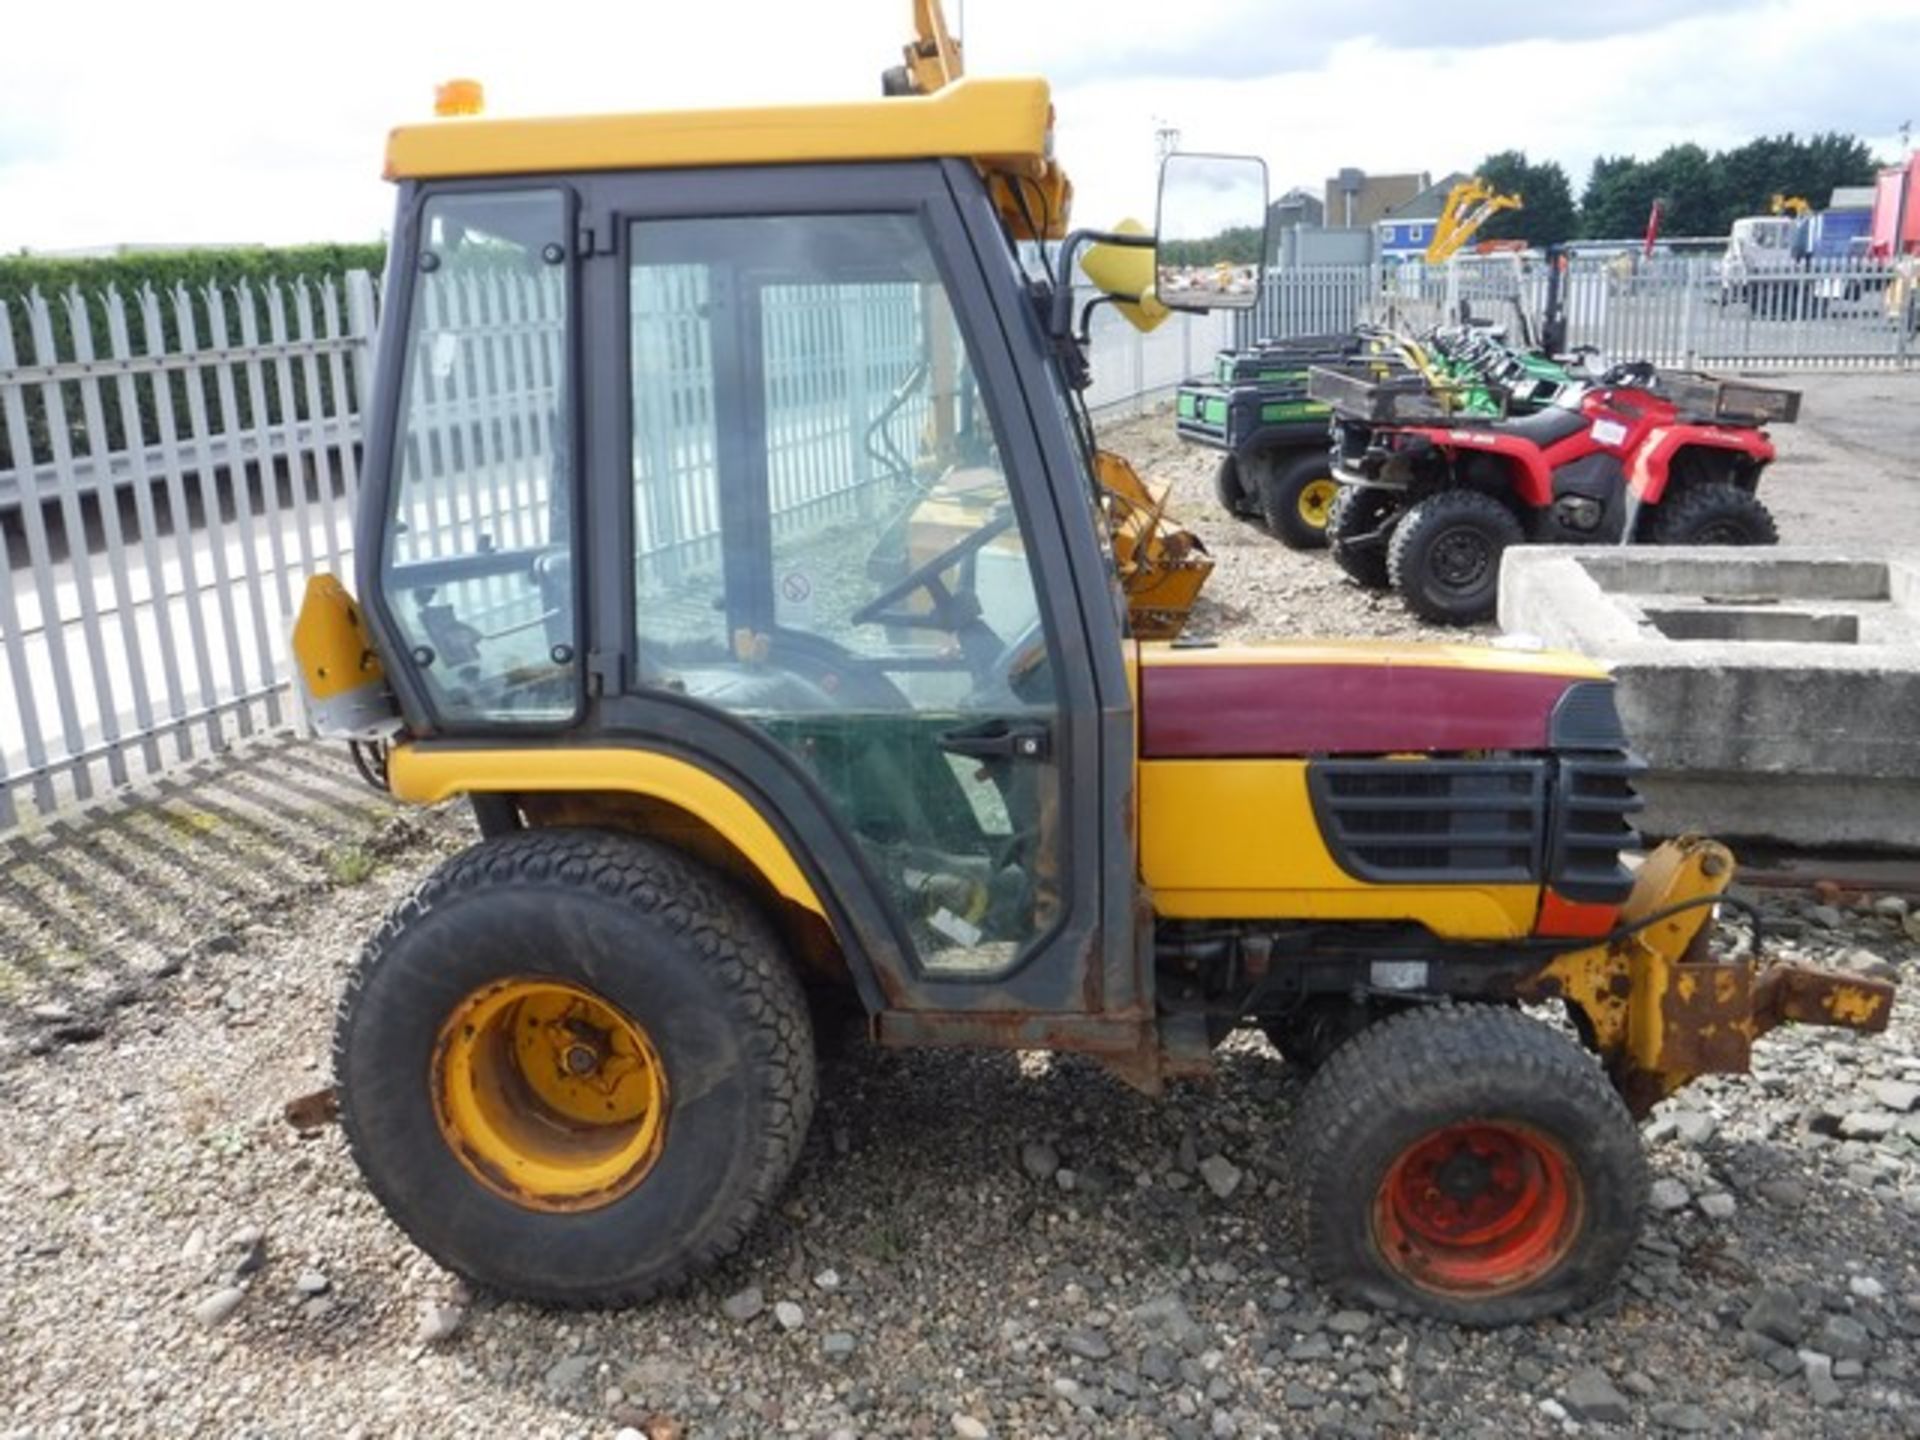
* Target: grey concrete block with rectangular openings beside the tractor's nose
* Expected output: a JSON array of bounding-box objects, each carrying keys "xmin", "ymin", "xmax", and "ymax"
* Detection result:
[{"xmin": 1500, "ymin": 545, "xmax": 1920, "ymax": 849}]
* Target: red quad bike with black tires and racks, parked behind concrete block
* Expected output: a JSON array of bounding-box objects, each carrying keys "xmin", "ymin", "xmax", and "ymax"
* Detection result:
[{"xmin": 1315, "ymin": 361, "xmax": 1799, "ymax": 624}]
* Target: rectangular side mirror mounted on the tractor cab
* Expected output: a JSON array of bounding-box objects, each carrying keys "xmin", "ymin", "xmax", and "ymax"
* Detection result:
[{"xmin": 1154, "ymin": 156, "xmax": 1267, "ymax": 309}]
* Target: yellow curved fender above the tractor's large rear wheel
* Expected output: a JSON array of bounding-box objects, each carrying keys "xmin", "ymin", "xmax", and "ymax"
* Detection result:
[{"xmin": 386, "ymin": 745, "xmax": 831, "ymax": 925}]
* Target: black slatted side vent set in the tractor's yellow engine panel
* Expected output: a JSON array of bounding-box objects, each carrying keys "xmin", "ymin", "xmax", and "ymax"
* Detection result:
[{"xmin": 1308, "ymin": 760, "xmax": 1548, "ymax": 883}]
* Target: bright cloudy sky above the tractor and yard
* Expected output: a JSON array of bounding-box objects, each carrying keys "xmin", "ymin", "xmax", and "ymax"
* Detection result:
[{"xmin": 0, "ymin": 0, "xmax": 1920, "ymax": 252}]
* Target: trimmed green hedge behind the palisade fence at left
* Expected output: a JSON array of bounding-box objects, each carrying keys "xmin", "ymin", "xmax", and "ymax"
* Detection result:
[{"xmin": 0, "ymin": 244, "xmax": 386, "ymax": 470}]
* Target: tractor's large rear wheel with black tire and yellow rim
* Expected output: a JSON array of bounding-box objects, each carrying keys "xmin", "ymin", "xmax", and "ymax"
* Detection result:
[{"xmin": 334, "ymin": 829, "xmax": 816, "ymax": 1306}]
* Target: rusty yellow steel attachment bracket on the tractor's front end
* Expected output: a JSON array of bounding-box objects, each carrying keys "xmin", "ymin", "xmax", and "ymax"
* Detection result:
[{"xmin": 1523, "ymin": 835, "xmax": 1893, "ymax": 1116}]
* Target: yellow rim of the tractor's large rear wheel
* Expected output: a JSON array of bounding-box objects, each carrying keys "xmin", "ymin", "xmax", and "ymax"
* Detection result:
[{"xmin": 432, "ymin": 979, "xmax": 666, "ymax": 1210}]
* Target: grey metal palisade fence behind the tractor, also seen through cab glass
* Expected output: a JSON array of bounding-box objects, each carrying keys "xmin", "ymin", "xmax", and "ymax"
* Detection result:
[{"xmin": 0, "ymin": 257, "xmax": 1920, "ymax": 831}]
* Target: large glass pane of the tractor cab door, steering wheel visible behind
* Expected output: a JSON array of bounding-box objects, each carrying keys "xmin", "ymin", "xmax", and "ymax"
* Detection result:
[{"xmin": 630, "ymin": 215, "xmax": 1062, "ymax": 973}]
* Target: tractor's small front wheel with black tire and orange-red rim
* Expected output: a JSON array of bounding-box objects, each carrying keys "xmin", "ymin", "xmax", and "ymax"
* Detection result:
[{"xmin": 1294, "ymin": 1004, "xmax": 1647, "ymax": 1327}]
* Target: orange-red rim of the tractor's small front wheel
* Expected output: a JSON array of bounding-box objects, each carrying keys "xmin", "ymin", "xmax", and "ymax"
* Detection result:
[{"xmin": 1373, "ymin": 1121, "xmax": 1586, "ymax": 1296}]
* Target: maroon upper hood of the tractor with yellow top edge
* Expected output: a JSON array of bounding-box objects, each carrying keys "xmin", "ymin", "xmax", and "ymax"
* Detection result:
[{"xmin": 1139, "ymin": 641, "xmax": 1624, "ymax": 760}]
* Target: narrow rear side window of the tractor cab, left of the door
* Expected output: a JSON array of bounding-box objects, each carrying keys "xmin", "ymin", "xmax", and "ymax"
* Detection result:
[{"xmin": 380, "ymin": 190, "xmax": 580, "ymax": 722}]
